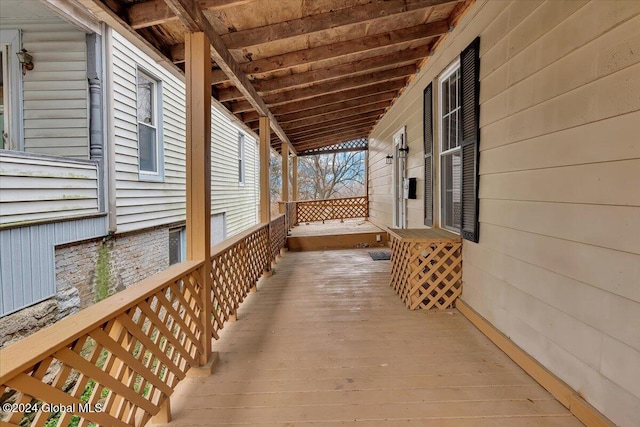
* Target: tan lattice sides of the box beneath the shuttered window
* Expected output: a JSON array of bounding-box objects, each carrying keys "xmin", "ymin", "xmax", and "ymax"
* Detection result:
[{"xmin": 391, "ymin": 235, "xmax": 462, "ymax": 310}]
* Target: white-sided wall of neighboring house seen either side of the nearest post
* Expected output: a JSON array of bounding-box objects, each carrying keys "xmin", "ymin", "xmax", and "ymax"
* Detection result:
[{"xmin": 111, "ymin": 31, "xmax": 257, "ymax": 235}]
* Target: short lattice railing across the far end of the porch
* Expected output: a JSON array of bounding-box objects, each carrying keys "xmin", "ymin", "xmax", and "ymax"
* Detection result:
[{"xmin": 296, "ymin": 196, "xmax": 369, "ymax": 223}]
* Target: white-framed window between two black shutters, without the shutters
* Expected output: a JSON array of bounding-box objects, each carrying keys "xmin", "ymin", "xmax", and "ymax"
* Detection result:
[{"xmin": 438, "ymin": 61, "xmax": 462, "ymax": 233}]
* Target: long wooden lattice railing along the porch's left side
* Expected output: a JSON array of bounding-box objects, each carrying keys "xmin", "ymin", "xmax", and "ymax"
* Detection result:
[{"xmin": 0, "ymin": 216, "xmax": 286, "ymax": 426}]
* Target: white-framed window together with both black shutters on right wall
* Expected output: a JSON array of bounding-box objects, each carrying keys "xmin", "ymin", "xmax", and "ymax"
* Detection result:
[{"xmin": 423, "ymin": 37, "xmax": 480, "ymax": 243}]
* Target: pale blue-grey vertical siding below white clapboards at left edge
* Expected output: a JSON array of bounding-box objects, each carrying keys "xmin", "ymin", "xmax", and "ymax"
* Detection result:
[{"xmin": 0, "ymin": 216, "xmax": 108, "ymax": 316}]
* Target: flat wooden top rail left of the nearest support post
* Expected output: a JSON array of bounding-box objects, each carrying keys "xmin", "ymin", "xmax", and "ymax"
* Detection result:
[{"xmin": 0, "ymin": 261, "xmax": 203, "ymax": 384}]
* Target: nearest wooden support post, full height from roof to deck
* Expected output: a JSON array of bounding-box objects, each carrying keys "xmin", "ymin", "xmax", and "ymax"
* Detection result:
[{"xmin": 185, "ymin": 32, "xmax": 213, "ymax": 365}]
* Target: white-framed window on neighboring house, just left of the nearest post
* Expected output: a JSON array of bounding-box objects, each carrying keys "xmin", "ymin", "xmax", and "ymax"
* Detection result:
[{"xmin": 136, "ymin": 69, "xmax": 163, "ymax": 180}]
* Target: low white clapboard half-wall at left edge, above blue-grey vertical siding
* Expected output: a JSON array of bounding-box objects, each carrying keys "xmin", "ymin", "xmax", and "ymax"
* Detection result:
[{"xmin": 0, "ymin": 151, "xmax": 99, "ymax": 225}]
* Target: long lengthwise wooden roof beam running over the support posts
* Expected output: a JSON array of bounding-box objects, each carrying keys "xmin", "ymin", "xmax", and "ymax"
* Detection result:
[{"xmin": 166, "ymin": 0, "xmax": 296, "ymax": 154}]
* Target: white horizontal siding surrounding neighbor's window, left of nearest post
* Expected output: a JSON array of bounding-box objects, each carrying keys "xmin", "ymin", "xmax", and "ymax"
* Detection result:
[{"xmin": 110, "ymin": 31, "xmax": 186, "ymax": 232}]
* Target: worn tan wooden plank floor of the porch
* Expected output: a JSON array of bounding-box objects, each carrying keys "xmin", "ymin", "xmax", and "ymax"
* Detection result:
[{"xmin": 162, "ymin": 249, "xmax": 582, "ymax": 427}]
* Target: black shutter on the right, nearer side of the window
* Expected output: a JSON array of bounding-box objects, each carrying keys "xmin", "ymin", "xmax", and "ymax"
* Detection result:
[{"xmin": 460, "ymin": 37, "xmax": 480, "ymax": 243}]
